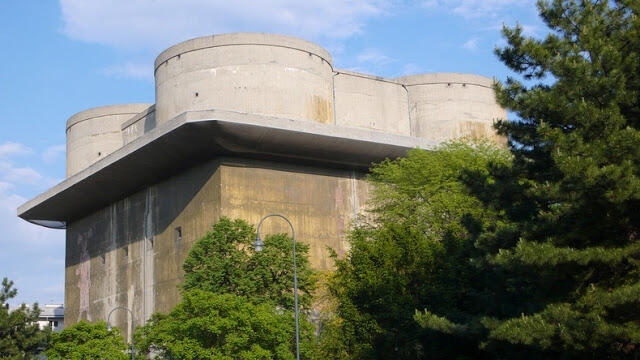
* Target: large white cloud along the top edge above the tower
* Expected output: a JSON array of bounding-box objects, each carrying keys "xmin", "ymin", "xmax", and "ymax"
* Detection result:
[{"xmin": 60, "ymin": 0, "xmax": 395, "ymax": 51}]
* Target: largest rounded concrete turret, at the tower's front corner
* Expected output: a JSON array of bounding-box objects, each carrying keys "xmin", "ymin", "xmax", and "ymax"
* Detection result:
[{"xmin": 155, "ymin": 33, "xmax": 334, "ymax": 126}]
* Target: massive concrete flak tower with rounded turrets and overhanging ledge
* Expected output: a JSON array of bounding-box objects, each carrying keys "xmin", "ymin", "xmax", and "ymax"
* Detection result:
[{"xmin": 18, "ymin": 33, "xmax": 506, "ymax": 336}]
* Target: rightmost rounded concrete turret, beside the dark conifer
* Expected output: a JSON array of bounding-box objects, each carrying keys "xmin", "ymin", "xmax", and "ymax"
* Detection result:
[{"xmin": 396, "ymin": 73, "xmax": 507, "ymax": 143}]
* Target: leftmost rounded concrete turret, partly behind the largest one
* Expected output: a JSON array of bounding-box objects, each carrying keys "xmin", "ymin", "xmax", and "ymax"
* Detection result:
[{"xmin": 67, "ymin": 104, "xmax": 149, "ymax": 177}]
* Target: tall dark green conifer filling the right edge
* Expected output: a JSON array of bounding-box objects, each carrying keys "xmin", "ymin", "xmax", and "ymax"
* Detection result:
[{"xmin": 416, "ymin": 0, "xmax": 640, "ymax": 359}]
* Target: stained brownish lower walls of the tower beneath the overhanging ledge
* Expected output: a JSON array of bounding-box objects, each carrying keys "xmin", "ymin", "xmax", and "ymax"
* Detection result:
[{"xmin": 65, "ymin": 158, "xmax": 368, "ymax": 338}]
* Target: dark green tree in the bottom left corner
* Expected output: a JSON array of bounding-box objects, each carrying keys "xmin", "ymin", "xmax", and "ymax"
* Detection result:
[{"xmin": 0, "ymin": 278, "xmax": 50, "ymax": 359}]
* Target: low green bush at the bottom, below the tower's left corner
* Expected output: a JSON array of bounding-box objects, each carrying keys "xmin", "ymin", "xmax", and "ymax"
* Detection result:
[{"xmin": 46, "ymin": 320, "xmax": 130, "ymax": 360}]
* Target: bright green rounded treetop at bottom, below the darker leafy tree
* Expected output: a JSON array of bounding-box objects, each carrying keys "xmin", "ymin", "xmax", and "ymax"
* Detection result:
[{"xmin": 137, "ymin": 289, "xmax": 314, "ymax": 360}]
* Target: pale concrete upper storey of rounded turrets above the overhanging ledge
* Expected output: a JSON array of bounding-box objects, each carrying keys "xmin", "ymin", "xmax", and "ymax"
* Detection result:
[{"xmin": 67, "ymin": 33, "xmax": 507, "ymax": 177}]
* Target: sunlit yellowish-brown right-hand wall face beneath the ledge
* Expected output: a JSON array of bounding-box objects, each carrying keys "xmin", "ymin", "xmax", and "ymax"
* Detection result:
[{"xmin": 221, "ymin": 162, "xmax": 368, "ymax": 270}]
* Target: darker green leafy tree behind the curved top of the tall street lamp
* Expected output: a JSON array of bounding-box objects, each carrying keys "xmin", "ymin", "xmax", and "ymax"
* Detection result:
[{"xmin": 182, "ymin": 217, "xmax": 314, "ymax": 309}]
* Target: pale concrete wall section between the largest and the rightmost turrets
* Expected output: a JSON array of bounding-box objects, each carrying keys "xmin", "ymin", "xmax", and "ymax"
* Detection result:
[{"xmin": 334, "ymin": 70, "xmax": 411, "ymax": 136}]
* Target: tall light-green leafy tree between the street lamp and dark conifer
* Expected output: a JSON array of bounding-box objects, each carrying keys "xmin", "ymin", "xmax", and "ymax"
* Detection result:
[{"xmin": 320, "ymin": 142, "xmax": 510, "ymax": 359}]
